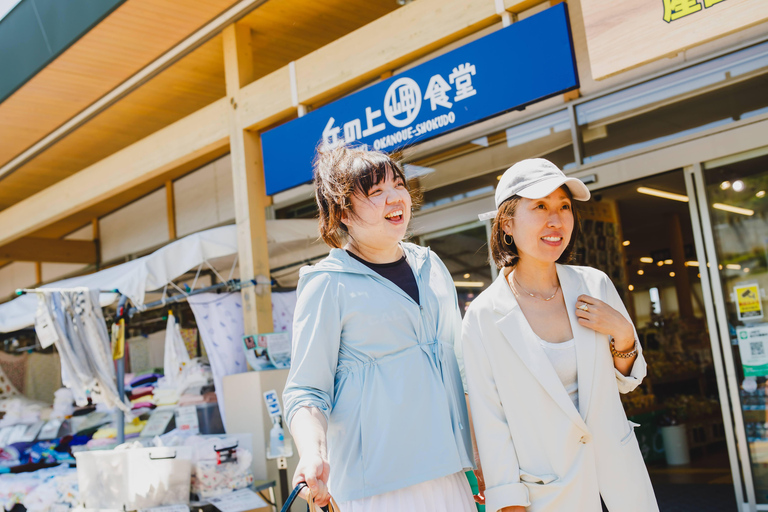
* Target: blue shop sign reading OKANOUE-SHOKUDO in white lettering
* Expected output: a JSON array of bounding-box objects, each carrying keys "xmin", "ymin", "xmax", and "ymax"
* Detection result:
[{"xmin": 261, "ymin": 3, "xmax": 579, "ymax": 195}]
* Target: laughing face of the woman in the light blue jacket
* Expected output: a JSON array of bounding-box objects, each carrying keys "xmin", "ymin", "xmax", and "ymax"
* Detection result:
[{"xmin": 341, "ymin": 169, "xmax": 411, "ymax": 251}]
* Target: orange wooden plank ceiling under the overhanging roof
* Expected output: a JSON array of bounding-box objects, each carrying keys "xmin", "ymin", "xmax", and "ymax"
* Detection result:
[{"xmin": 0, "ymin": 0, "xmax": 399, "ymax": 238}]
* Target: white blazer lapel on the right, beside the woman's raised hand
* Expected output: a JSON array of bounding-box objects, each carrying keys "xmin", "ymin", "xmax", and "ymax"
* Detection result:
[{"xmin": 557, "ymin": 265, "xmax": 597, "ymax": 420}]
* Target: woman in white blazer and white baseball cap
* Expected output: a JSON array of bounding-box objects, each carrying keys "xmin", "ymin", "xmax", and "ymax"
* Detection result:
[{"xmin": 462, "ymin": 159, "xmax": 658, "ymax": 512}]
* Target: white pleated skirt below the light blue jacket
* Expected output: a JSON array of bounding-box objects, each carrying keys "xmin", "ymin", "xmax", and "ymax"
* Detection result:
[{"xmin": 339, "ymin": 472, "xmax": 477, "ymax": 512}]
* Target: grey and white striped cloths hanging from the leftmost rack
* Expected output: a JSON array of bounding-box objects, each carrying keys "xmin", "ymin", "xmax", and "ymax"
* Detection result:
[{"xmin": 35, "ymin": 288, "xmax": 130, "ymax": 412}]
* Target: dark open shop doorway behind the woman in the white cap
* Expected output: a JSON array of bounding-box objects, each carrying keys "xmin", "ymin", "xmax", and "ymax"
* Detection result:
[{"xmin": 576, "ymin": 170, "xmax": 735, "ymax": 510}]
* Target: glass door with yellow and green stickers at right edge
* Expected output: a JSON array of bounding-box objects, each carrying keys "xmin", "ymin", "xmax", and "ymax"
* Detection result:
[{"xmin": 699, "ymin": 150, "xmax": 768, "ymax": 510}]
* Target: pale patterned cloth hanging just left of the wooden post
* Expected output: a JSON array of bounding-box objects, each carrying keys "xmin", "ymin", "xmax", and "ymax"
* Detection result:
[{"xmin": 189, "ymin": 293, "xmax": 248, "ymax": 425}]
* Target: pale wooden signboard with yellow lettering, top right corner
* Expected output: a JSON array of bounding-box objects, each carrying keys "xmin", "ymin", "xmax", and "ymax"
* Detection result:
[{"xmin": 581, "ymin": 0, "xmax": 768, "ymax": 80}]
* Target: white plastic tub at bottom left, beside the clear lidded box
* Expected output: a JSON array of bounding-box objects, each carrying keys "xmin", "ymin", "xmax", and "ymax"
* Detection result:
[{"xmin": 75, "ymin": 446, "xmax": 192, "ymax": 510}]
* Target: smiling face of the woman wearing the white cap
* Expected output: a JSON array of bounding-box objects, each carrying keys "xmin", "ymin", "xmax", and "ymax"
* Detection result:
[{"xmin": 503, "ymin": 188, "xmax": 574, "ymax": 263}]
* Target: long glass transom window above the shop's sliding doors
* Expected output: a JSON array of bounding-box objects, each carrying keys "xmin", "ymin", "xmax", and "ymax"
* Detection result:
[{"xmin": 576, "ymin": 43, "xmax": 768, "ymax": 163}]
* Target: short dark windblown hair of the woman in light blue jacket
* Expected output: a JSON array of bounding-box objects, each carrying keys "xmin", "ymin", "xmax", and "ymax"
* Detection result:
[{"xmin": 313, "ymin": 144, "xmax": 421, "ymax": 248}]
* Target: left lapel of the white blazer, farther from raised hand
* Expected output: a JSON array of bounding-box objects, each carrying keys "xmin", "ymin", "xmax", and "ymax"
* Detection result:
[{"xmin": 493, "ymin": 273, "xmax": 589, "ymax": 432}]
